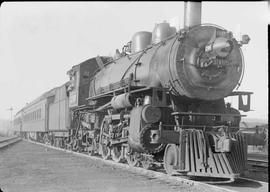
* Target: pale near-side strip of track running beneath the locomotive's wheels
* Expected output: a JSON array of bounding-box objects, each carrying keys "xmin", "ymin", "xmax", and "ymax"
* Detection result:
[{"xmin": 25, "ymin": 140, "xmax": 268, "ymax": 192}]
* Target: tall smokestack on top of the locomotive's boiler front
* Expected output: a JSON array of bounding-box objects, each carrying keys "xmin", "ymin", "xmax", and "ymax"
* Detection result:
[{"xmin": 184, "ymin": 1, "xmax": 202, "ymax": 28}]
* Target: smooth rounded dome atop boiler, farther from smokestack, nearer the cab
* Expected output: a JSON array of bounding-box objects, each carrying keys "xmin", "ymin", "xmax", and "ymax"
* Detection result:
[{"xmin": 131, "ymin": 31, "xmax": 152, "ymax": 53}]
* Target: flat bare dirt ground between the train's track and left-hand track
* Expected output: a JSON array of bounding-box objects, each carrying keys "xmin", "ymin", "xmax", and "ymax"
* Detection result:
[{"xmin": 0, "ymin": 141, "xmax": 198, "ymax": 192}]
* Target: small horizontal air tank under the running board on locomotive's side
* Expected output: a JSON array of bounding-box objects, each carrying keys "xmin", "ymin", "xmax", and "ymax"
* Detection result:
[{"xmin": 111, "ymin": 93, "xmax": 133, "ymax": 109}]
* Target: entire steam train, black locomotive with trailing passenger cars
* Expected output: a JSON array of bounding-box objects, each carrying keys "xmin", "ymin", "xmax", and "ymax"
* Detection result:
[{"xmin": 14, "ymin": 2, "xmax": 252, "ymax": 181}]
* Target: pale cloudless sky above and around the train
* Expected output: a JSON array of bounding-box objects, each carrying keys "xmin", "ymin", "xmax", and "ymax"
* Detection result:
[{"xmin": 0, "ymin": 1, "xmax": 270, "ymax": 119}]
